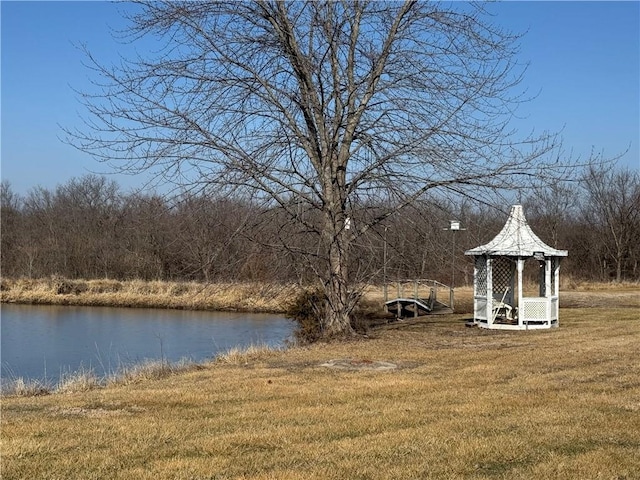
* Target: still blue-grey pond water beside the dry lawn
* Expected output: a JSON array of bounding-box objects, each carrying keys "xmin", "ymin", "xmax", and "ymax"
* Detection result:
[{"xmin": 0, "ymin": 304, "xmax": 293, "ymax": 383}]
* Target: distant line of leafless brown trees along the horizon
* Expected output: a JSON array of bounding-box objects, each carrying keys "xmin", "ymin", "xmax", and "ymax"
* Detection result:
[{"xmin": 0, "ymin": 167, "xmax": 640, "ymax": 285}]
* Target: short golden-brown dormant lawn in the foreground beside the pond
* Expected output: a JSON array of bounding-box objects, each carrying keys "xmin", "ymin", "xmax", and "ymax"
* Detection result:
[{"xmin": 1, "ymin": 305, "xmax": 640, "ymax": 480}]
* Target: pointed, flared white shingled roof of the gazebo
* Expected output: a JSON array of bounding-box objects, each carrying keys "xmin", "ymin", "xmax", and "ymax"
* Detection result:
[{"xmin": 465, "ymin": 205, "xmax": 569, "ymax": 257}]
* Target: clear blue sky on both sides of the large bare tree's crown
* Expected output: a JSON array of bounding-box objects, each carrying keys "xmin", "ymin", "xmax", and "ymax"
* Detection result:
[{"xmin": 0, "ymin": 1, "xmax": 640, "ymax": 194}]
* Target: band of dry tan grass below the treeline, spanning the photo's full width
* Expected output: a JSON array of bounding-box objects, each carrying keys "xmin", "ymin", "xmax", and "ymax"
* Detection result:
[{"xmin": 0, "ymin": 276, "xmax": 640, "ymax": 318}]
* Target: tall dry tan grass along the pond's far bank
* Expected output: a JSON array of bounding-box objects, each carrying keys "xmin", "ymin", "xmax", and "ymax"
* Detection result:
[{"xmin": 0, "ymin": 277, "xmax": 299, "ymax": 313}]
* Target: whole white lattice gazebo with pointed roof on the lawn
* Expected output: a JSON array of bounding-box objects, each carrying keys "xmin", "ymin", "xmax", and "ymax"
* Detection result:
[{"xmin": 465, "ymin": 205, "xmax": 568, "ymax": 330}]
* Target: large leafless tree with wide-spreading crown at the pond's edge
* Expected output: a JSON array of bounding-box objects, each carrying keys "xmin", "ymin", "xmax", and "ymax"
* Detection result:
[{"xmin": 68, "ymin": 0, "xmax": 558, "ymax": 337}]
